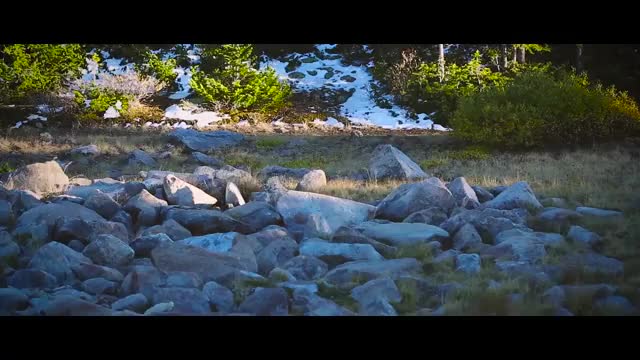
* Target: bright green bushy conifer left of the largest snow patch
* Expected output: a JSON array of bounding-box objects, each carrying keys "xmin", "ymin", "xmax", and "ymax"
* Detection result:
[{"xmin": 190, "ymin": 44, "xmax": 291, "ymax": 111}]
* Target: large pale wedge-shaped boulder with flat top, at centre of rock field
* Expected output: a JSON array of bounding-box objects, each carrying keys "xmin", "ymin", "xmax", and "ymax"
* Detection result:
[{"xmin": 276, "ymin": 191, "xmax": 375, "ymax": 238}]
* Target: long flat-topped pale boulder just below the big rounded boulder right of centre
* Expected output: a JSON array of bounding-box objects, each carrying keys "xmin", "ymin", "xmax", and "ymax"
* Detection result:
[{"xmin": 354, "ymin": 221, "xmax": 449, "ymax": 246}]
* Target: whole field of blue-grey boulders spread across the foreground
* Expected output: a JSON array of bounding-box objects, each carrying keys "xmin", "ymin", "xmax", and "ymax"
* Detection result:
[{"xmin": 0, "ymin": 130, "xmax": 637, "ymax": 316}]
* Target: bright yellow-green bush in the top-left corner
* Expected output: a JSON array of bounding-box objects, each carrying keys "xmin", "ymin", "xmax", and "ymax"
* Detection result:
[{"xmin": 0, "ymin": 44, "xmax": 86, "ymax": 101}]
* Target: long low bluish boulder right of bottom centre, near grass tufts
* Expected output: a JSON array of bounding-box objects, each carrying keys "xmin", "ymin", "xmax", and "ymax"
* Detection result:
[{"xmin": 323, "ymin": 258, "xmax": 422, "ymax": 285}]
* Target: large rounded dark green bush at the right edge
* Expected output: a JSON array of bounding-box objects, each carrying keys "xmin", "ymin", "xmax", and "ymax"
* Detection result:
[{"xmin": 452, "ymin": 71, "xmax": 640, "ymax": 147}]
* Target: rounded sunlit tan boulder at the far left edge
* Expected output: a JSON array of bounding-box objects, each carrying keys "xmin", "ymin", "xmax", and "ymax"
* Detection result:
[{"xmin": 4, "ymin": 160, "xmax": 69, "ymax": 195}]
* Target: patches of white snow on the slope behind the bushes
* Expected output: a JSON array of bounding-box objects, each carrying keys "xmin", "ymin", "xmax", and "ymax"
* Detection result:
[{"xmin": 16, "ymin": 44, "xmax": 448, "ymax": 131}]
